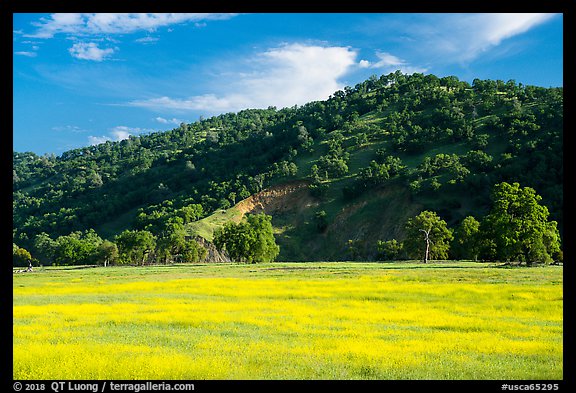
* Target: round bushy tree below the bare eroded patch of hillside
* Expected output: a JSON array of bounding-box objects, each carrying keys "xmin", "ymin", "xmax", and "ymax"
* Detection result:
[{"xmin": 214, "ymin": 213, "xmax": 280, "ymax": 263}]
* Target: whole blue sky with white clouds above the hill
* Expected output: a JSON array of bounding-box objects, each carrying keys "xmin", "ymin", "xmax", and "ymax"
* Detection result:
[{"xmin": 13, "ymin": 13, "xmax": 563, "ymax": 155}]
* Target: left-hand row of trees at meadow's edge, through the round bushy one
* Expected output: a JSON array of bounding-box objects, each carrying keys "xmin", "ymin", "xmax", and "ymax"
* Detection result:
[{"xmin": 13, "ymin": 214, "xmax": 280, "ymax": 266}]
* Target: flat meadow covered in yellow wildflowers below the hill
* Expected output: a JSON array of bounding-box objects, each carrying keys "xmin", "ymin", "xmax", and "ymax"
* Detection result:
[{"xmin": 13, "ymin": 262, "xmax": 563, "ymax": 380}]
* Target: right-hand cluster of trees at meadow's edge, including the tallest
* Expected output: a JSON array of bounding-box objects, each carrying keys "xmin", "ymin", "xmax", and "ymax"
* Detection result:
[{"xmin": 366, "ymin": 182, "xmax": 563, "ymax": 265}]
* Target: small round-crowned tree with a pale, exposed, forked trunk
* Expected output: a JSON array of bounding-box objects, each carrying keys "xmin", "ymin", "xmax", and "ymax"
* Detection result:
[{"xmin": 404, "ymin": 210, "xmax": 453, "ymax": 262}]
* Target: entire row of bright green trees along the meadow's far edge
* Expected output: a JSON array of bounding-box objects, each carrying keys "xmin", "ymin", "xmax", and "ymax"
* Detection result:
[{"xmin": 13, "ymin": 182, "xmax": 563, "ymax": 266}]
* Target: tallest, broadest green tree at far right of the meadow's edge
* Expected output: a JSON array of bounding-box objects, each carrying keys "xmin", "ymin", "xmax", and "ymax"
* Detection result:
[{"xmin": 480, "ymin": 182, "xmax": 560, "ymax": 265}]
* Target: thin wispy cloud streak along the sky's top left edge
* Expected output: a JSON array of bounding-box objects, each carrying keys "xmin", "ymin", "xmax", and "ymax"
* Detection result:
[{"xmin": 26, "ymin": 13, "xmax": 237, "ymax": 38}]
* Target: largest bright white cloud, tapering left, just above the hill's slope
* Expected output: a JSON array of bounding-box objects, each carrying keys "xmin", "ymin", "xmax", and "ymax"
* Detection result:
[{"xmin": 128, "ymin": 43, "xmax": 357, "ymax": 113}]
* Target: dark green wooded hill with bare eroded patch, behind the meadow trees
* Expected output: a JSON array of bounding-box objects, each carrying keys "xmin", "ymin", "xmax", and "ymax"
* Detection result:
[{"xmin": 13, "ymin": 72, "xmax": 563, "ymax": 260}]
